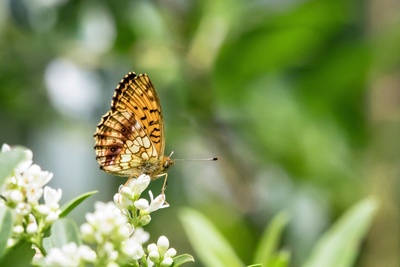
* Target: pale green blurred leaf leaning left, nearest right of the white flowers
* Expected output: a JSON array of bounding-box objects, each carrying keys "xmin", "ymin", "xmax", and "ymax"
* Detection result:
[{"xmin": 179, "ymin": 208, "xmax": 244, "ymax": 267}]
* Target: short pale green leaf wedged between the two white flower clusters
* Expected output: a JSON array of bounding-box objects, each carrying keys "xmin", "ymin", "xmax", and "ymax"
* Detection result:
[{"xmin": 44, "ymin": 218, "xmax": 82, "ymax": 252}]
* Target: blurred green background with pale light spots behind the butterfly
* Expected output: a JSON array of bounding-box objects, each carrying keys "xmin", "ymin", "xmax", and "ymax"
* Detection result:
[{"xmin": 0, "ymin": 0, "xmax": 400, "ymax": 267}]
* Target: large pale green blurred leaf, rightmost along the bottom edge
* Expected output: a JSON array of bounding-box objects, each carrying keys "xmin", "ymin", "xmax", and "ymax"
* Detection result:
[{"xmin": 304, "ymin": 197, "xmax": 378, "ymax": 267}]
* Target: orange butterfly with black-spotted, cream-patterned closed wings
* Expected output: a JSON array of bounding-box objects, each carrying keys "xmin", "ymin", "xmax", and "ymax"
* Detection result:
[{"xmin": 94, "ymin": 72, "xmax": 174, "ymax": 191}]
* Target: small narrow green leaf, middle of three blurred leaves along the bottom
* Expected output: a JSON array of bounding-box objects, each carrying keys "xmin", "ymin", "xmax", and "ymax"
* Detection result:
[{"xmin": 253, "ymin": 212, "xmax": 289, "ymax": 266}]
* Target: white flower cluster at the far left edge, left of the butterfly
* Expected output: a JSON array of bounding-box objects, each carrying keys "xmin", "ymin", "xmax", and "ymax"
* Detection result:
[{"xmin": 0, "ymin": 144, "xmax": 62, "ymax": 251}]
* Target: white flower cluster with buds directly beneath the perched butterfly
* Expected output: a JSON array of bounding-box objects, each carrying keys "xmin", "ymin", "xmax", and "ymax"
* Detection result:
[{"xmin": 45, "ymin": 175, "xmax": 176, "ymax": 267}]
